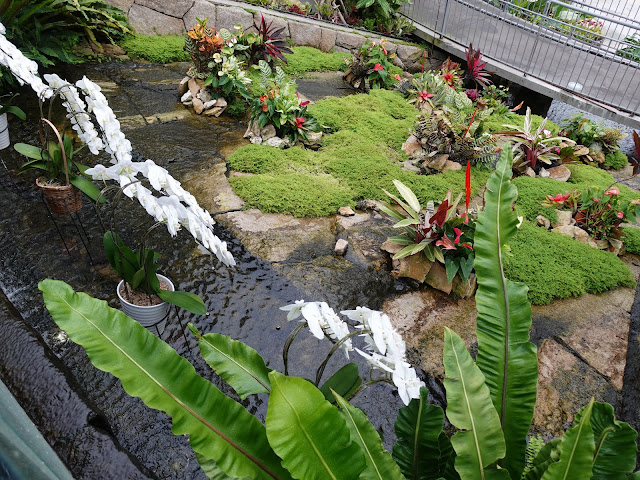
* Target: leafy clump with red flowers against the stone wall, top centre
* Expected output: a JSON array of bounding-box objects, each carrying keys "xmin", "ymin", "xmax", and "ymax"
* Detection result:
[{"xmin": 343, "ymin": 39, "xmax": 401, "ymax": 92}]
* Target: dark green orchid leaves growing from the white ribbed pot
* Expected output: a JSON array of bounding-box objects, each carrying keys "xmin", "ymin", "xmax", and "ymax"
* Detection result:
[{"xmin": 103, "ymin": 231, "xmax": 207, "ymax": 315}]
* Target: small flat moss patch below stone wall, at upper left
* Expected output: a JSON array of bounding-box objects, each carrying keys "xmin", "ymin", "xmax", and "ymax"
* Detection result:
[{"xmin": 121, "ymin": 35, "xmax": 191, "ymax": 63}]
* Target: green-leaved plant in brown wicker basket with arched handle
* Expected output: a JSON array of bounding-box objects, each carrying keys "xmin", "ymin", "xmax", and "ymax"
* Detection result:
[{"xmin": 14, "ymin": 118, "xmax": 100, "ymax": 213}]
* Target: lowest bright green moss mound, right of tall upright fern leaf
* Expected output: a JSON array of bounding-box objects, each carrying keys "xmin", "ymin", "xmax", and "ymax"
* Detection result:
[{"xmin": 505, "ymin": 222, "xmax": 635, "ymax": 305}]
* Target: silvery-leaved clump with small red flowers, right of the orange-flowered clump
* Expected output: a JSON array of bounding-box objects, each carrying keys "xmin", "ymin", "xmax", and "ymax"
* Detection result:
[{"xmin": 250, "ymin": 60, "xmax": 322, "ymax": 143}]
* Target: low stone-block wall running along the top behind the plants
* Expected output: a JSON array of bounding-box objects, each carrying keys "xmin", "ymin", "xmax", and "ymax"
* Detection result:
[{"xmin": 107, "ymin": 0, "xmax": 423, "ymax": 71}]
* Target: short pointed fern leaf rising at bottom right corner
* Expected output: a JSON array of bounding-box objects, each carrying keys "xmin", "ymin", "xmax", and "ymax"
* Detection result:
[{"xmin": 542, "ymin": 400, "xmax": 596, "ymax": 480}]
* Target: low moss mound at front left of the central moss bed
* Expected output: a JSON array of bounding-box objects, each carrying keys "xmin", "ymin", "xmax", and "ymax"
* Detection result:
[{"xmin": 229, "ymin": 172, "xmax": 355, "ymax": 217}]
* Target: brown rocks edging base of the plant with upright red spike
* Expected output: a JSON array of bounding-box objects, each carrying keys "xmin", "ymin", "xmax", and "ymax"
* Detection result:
[{"xmin": 380, "ymin": 240, "xmax": 477, "ymax": 298}]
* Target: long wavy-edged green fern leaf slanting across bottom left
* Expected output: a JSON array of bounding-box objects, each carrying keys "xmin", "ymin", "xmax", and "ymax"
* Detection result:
[{"xmin": 38, "ymin": 280, "xmax": 291, "ymax": 479}]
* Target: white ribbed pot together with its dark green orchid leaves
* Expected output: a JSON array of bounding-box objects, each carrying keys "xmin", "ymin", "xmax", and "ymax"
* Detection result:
[{"xmin": 103, "ymin": 231, "xmax": 207, "ymax": 327}]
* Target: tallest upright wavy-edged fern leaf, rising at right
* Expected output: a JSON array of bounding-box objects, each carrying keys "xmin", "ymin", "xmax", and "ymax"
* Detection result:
[{"xmin": 474, "ymin": 145, "xmax": 538, "ymax": 478}]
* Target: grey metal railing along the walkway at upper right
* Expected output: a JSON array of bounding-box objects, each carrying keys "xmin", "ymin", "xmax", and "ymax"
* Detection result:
[{"xmin": 401, "ymin": 0, "xmax": 640, "ymax": 115}]
